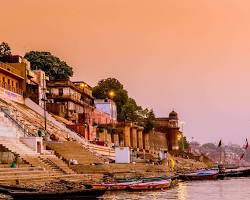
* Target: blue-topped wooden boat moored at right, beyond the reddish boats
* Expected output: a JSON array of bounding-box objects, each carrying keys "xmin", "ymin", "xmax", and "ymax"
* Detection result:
[{"xmin": 179, "ymin": 169, "xmax": 221, "ymax": 181}]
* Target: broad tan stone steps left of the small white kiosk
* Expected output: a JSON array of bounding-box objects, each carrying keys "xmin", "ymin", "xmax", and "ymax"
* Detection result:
[{"xmin": 46, "ymin": 141, "xmax": 104, "ymax": 165}]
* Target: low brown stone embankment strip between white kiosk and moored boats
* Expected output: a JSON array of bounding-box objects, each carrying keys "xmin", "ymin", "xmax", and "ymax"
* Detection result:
[{"xmin": 72, "ymin": 157, "xmax": 208, "ymax": 180}]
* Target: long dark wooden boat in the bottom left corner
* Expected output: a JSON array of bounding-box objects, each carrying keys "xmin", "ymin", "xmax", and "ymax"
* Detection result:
[{"xmin": 0, "ymin": 188, "xmax": 106, "ymax": 200}]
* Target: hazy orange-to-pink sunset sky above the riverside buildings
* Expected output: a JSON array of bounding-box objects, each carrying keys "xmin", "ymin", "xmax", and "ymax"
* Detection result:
[{"xmin": 0, "ymin": 0, "xmax": 250, "ymax": 144}]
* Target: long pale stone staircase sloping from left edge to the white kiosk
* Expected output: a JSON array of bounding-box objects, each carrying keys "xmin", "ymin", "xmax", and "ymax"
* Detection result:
[{"xmin": 0, "ymin": 99, "xmax": 114, "ymax": 162}]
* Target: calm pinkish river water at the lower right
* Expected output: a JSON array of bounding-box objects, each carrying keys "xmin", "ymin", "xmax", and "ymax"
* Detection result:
[{"xmin": 101, "ymin": 178, "xmax": 250, "ymax": 200}]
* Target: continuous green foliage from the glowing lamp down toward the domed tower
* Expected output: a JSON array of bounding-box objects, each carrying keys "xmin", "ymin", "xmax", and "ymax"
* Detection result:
[{"xmin": 93, "ymin": 78, "xmax": 155, "ymax": 132}]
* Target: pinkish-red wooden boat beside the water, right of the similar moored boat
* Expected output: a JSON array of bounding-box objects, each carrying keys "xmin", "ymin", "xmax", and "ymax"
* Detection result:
[{"xmin": 129, "ymin": 179, "xmax": 171, "ymax": 190}]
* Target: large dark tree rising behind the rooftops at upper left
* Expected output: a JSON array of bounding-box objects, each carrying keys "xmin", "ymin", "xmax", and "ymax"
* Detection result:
[{"xmin": 24, "ymin": 51, "xmax": 73, "ymax": 80}]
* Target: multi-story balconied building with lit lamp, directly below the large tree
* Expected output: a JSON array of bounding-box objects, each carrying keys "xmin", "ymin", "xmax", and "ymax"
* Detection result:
[{"xmin": 47, "ymin": 80, "xmax": 94, "ymax": 124}]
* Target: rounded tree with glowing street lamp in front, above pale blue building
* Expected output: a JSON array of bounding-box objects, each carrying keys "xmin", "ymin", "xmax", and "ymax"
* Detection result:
[{"xmin": 93, "ymin": 78, "xmax": 128, "ymax": 121}]
